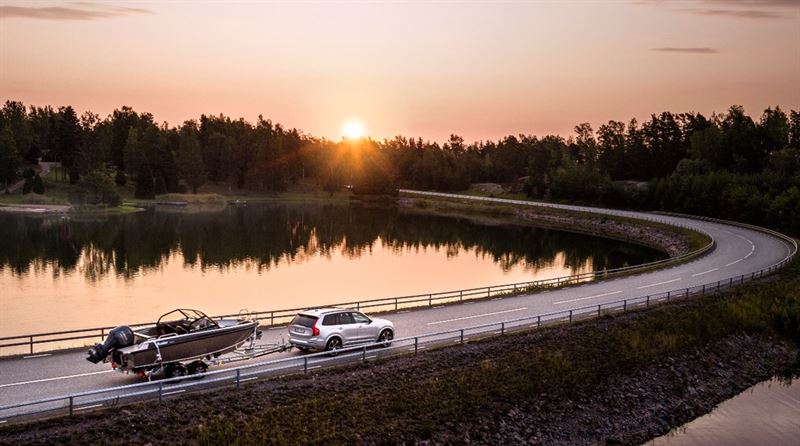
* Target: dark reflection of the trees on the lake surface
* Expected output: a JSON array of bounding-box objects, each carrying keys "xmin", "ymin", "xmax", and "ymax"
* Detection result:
[{"xmin": 0, "ymin": 206, "xmax": 661, "ymax": 281}]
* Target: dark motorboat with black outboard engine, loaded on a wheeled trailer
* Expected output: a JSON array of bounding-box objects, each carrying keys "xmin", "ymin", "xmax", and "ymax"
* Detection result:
[{"xmin": 86, "ymin": 308, "xmax": 260, "ymax": 379}]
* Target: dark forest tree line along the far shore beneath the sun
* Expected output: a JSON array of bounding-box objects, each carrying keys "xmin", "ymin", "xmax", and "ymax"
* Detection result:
[{"xmin": 0, "ymin": 101, "xmax": 800, "ymax": 234}]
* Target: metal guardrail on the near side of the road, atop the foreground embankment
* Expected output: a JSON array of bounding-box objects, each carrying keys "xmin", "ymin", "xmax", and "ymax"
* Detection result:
[{"xmin": 0, "ymin": 236, "xmax": 797, "ymax": 424}]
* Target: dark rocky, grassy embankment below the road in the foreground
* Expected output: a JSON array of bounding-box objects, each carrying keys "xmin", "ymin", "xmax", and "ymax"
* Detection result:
[{"xmin": 0, "ymin": 288, "xmax": 798, "ymax": 445}]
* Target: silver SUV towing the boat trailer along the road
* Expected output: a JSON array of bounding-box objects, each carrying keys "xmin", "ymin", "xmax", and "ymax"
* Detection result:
[{"xmin": 289, "ymin": 308, "xmax": 394, "ymax": 354}]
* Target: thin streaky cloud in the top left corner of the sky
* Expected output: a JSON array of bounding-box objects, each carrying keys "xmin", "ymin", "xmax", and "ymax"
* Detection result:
[{"xmin": 0, "ymin": 2, "xmax": 153, "ymax": 20}]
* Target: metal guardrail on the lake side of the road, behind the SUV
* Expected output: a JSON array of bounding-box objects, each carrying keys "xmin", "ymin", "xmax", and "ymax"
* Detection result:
[{"xmin": 0, "ymin": 228, "xmax": 716, "ymax": 356}]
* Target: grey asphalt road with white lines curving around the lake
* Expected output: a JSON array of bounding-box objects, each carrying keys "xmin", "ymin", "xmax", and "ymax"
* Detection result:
[{"xmin": 0, "ymin": 191, "xmax": 794, "ymax": 412}]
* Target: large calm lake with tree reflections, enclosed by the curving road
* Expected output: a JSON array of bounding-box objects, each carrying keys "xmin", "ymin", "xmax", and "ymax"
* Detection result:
[{"xmin": 0, "ymin": 205, "xmax": 663, "ymax": 336}]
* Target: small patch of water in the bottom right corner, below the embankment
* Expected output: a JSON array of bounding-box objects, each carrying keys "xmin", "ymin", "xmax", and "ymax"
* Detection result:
[{"xmin": 647, "ymin": 378, "xmax": 800, "ymax": 446}]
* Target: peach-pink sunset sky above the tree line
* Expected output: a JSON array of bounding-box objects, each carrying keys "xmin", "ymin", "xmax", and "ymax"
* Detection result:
[{"xmin": 0, "ymin": 0, "xmax": 800, "ymax": 141}]
